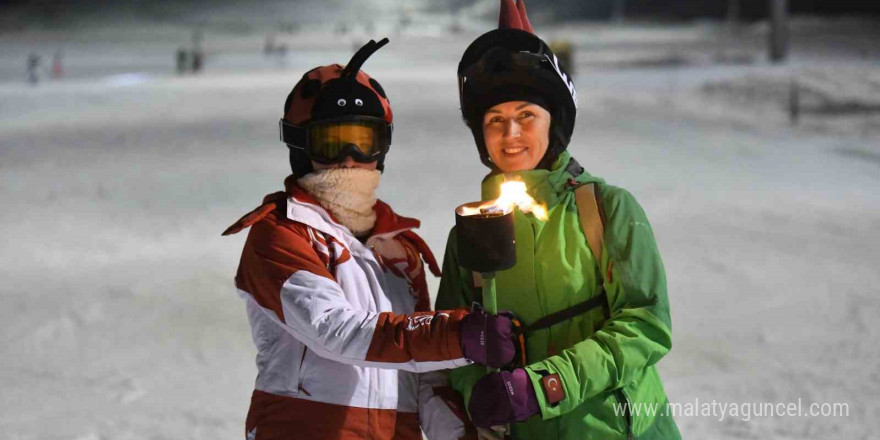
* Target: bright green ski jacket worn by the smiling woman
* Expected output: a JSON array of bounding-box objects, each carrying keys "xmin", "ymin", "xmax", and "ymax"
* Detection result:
[{"xmin": 435, "ymin": 152, "xmax": 681, "ymax": 440}]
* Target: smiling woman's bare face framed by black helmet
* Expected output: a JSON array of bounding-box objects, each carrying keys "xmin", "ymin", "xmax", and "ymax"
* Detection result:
[{"xmin": 483, "ymin": 101, "xmax": 550, "ymax": 173}]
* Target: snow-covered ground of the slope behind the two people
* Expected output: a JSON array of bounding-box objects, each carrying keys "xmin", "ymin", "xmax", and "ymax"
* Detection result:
[{"xmin": 0, "ymin": 13, "xmax": 880, "ymax": 440}]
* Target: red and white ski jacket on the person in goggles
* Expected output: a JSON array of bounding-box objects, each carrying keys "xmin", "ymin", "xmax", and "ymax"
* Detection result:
[{"xmin": 224, "ymin": 176, "xmax": 475, "ymax": 440}]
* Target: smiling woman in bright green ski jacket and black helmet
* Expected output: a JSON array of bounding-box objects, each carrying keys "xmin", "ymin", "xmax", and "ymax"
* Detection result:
[{"xmin": 436, "ymin": 0, "xmax": 681, "ymax": 440}]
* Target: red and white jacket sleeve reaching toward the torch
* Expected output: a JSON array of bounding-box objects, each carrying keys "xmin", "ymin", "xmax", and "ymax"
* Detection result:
[{"xmin": 236, "ymin": 216, "xmax": 468, "ymax": 372}]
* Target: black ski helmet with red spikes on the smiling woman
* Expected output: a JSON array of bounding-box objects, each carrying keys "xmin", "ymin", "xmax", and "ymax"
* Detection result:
[{"xmin": 458, "ymin": 0, "xmax": 577, "ymax": 170}]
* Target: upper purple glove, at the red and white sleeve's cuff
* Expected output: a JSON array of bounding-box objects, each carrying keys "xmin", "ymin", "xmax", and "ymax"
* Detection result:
[{"xmin": 461, "ymin": 311, "xmax": 516, "ymax": 368}]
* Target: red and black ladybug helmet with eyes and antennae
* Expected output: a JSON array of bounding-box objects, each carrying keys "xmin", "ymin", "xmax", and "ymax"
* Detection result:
[{"xmin": 279, "ymin": 38, "xmax": 394, "ymax": 176}]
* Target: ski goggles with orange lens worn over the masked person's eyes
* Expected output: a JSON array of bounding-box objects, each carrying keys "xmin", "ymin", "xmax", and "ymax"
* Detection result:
[{"xmin": 279, "ymin": 116, "xmax": 392, "ymax": 164}]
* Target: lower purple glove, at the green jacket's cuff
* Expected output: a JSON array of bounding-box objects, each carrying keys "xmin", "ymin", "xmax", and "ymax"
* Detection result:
[{"xmin": 468, "ymin": 368, "xmax": 540, "ymax": 428}]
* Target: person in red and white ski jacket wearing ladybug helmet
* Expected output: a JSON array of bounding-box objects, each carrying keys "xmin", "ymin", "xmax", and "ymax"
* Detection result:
[{"xmin": 224, "ymin": 39, "xmax": 514, "ymax": 440}]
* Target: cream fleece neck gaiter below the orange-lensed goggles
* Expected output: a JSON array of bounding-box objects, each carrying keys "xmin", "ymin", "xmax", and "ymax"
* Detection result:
[{"xmin": 296, "ymin": 168, "xmax": 382, "ymax": 237}]
